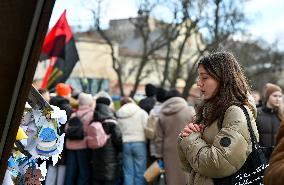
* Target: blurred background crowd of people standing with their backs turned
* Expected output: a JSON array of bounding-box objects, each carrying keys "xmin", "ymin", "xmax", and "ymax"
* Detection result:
[{"xmin": 39, "ymin": 83, "xmax": 194, "ymax": 185}]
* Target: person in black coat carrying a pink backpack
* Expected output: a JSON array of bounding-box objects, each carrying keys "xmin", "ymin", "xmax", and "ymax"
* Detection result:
[{"xmin": 91, "ymin": 97, "xmax": 122, "ymax": 185}]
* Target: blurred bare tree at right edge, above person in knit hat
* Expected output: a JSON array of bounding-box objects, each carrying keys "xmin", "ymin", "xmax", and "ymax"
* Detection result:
[{"xmin": 223, "ymin": 39, "xmax": 284, "ymax": 92}]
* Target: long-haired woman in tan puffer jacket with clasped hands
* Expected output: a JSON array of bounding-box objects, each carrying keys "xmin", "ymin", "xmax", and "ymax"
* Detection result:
[{"xmin": 178, "ymin": 52, "xmax": 258, "ymax": 185}]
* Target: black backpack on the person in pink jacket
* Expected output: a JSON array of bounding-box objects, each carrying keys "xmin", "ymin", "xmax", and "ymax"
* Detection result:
[{"xmin": 66, "ymin": 112, "xmax": 88, "ymax": 140}]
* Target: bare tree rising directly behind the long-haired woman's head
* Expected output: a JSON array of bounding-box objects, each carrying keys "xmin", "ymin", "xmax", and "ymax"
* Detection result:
[{"xmin": 183, "ymin": 0, "xmax": 247, "ymax": 97}]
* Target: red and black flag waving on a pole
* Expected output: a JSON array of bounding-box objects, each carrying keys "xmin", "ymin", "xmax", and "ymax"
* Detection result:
[{"xmin": 41, "ymin": 10, "xmax": 79, "ymax": 89}]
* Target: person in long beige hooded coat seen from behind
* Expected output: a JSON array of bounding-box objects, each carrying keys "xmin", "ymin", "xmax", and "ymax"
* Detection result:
[{"xmin": 155, "ymin": 90, "xmax": 195, "ymax": 185}]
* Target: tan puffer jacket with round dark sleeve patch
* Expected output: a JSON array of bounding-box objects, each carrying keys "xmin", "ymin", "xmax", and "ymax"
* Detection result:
[{"xmin": 178, "ymin": 106, "xmax": 259, "ymax": 185}]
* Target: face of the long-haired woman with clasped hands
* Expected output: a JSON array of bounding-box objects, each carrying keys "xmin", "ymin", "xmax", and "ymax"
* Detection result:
[{"xmin": 197, "ymin": 65, "xmax": 219, "ymax": 100}]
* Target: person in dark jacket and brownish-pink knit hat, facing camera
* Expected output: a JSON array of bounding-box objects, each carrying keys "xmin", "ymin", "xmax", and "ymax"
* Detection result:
[{"xmin": 256, "ymin": 83, "xmax": 283, "ymax": 158}]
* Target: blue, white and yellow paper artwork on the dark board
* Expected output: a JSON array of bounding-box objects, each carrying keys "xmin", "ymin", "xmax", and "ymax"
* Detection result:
[{"xmin": 5, "ymin": 88, "xmax": 67, "ymax": 185}]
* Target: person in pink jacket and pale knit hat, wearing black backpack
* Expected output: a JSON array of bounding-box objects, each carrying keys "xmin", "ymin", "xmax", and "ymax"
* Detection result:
[{"xmin": 65, "ymin": 92, "xmax": 94, "ymax": 185}]
